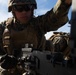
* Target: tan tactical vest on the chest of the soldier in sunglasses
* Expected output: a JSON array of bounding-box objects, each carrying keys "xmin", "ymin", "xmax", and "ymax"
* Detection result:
[{"xmin": 3, "ymin": 19, "xmax": 45, "ymax": 55}]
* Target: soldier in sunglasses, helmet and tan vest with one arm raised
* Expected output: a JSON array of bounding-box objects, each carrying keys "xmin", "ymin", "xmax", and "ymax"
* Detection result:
[{"xmin": 1, "ymin": 0, "xmax": 71, "ymax": 74}]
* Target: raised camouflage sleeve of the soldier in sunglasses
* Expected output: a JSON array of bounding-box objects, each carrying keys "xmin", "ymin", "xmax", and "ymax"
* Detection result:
[{"xmin": 37, "ymin": 0, "xmax": 71, "ymax": 34}]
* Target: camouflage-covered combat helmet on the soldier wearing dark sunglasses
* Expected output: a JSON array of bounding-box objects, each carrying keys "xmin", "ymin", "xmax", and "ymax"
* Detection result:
[{"xmin": 8, "ymin": 0, "xmax": 37, "ymax": 12}]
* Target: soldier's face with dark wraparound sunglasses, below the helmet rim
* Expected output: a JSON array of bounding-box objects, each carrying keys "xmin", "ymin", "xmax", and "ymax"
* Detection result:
[{"xmin": 13, "ymin": 5, "xmax": 33, "ymax": 23}]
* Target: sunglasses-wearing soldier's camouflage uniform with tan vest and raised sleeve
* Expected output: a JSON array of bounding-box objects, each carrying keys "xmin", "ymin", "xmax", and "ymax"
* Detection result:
[{"xmin": 0, "ymin": 2, "xmax": 70, "ymax": 55}]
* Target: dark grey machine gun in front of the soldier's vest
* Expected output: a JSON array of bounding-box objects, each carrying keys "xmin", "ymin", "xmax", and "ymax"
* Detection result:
[{"xmin": 21, "ymin": 50, "xmax": 76, "ymax": 75}]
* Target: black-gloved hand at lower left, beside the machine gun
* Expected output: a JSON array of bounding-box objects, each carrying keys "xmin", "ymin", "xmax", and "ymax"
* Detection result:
[{"xmin": 0, "ymin": 54, "xmax": 18, "ymax": 69}]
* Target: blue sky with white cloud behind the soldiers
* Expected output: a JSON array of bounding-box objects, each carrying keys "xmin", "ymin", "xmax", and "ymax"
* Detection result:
[{"xmin": 0, "ymin": 0, "xmax": 71, "ymax": 39}]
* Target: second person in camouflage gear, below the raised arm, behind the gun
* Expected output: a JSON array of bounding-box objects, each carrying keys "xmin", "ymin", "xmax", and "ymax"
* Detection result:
[{"xmin": 49, "ymin": 32, "xmax": 71, "ymax": 59}]
